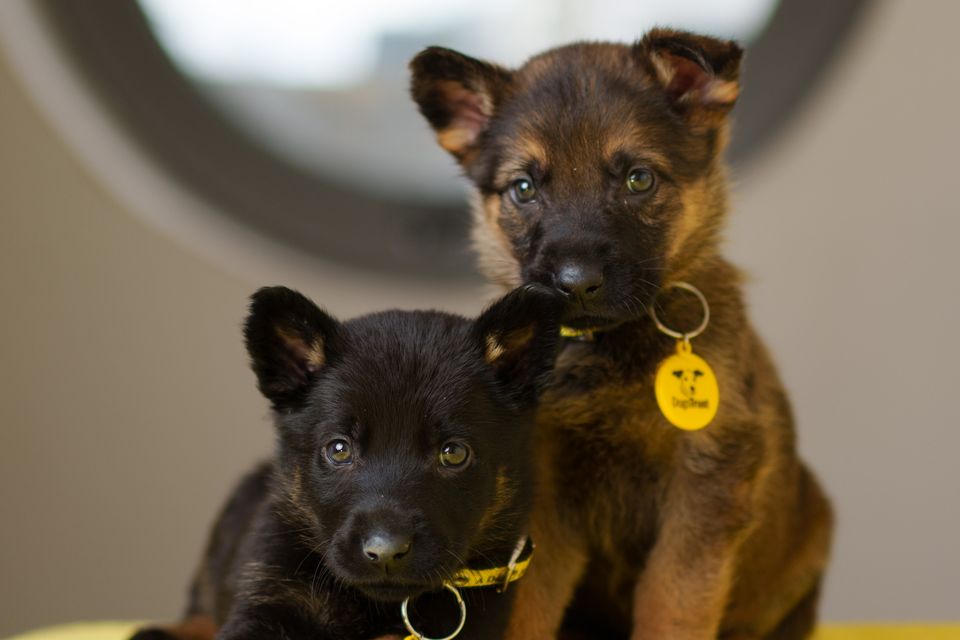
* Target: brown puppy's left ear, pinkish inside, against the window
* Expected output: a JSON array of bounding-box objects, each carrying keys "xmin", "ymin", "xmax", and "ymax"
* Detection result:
[{"xmin": 410, "ymin": 47, "xmax": 510, "ymax": 164}]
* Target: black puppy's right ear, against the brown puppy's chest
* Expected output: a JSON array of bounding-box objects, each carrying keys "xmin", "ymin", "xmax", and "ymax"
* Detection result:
[{"xmin": 474, "ymin": 285, "xmax": 563, "ymax": 404}]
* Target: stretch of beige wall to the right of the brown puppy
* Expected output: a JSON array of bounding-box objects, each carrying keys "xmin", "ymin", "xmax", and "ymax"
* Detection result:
[{"xmin": 730, "ymin": 0, "xmax": 960, "ymax": 619}]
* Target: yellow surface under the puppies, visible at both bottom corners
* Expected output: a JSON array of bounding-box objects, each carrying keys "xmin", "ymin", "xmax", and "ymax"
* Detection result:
[{"xmin": 8, "ymin": 622, "xmax": 960, "ymax": 640}]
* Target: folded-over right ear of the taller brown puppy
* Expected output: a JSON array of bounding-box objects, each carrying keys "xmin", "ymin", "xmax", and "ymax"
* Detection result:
[{"xmin": 634, "ymin": 29, "xmax": 743, "ymax": 126}]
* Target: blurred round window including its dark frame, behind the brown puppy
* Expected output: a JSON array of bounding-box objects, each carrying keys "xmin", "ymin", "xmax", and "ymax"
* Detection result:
[{"xmin": 39, "ymin": 0, "xmax": 869, "ymax": 281}]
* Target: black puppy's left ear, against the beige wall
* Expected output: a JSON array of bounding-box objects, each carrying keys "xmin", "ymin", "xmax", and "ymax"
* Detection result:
[{"xmin": 243, "ymin": 287, "xmax": 340, "ymax": 411}]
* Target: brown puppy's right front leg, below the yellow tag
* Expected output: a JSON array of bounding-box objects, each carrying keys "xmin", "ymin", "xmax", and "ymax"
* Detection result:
[{"xmin": 630, "ymin": 440, "xmax": 756, "ymax": 640}]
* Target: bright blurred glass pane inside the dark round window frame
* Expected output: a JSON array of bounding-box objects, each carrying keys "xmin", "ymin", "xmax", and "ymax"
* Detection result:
[{"xmin": 139, "ymin": 0, "xmax": 778, "ymax": 204}]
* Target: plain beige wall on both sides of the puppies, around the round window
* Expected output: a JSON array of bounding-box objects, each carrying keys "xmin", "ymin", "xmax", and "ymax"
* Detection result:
[{"xmin": 0, "ymin": 0, "xmax": 960, "ymax": 635}]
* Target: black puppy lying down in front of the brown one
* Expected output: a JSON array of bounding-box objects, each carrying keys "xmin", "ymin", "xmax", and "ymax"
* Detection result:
[{"xmin": 134, "ymin": 287, "xmax": 560, "ymax": 640}]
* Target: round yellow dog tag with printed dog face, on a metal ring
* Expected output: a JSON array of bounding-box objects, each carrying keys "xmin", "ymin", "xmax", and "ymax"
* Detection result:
[{"xmin": 654, "ymin": 340, "xmax": 720, "ymax": 431}]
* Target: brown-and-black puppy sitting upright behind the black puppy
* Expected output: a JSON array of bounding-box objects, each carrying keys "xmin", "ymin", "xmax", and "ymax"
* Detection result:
[{"xmin": 411, "ymin": 30, "xmax": 832, "ymax": 640}]
